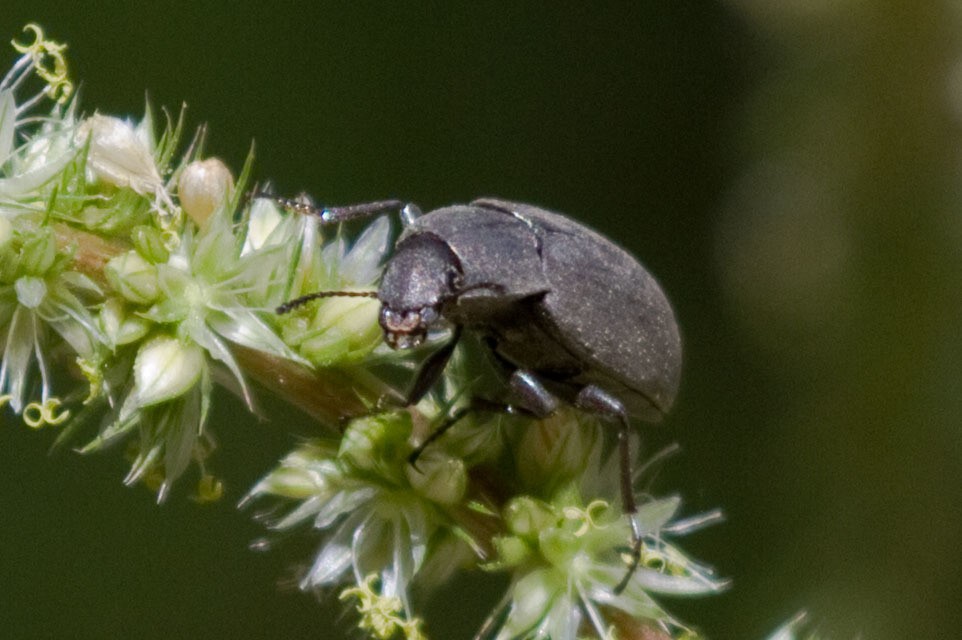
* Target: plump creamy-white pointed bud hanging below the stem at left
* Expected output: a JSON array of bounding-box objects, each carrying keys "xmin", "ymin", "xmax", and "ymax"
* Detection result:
[{"xmin": 134, "ymin": 336, "xmax": 204, "ymax": 407}]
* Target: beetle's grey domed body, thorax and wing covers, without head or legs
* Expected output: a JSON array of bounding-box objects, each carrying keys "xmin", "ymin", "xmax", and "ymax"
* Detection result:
[{"xmin": 398, "ymin": 199, "xmax": 681, "ymax": 421}]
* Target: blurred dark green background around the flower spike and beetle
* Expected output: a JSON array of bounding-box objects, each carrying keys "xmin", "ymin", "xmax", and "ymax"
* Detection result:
[{"xmin": 0, "ymin": 0, "xmax": 962, "ymax": 639}]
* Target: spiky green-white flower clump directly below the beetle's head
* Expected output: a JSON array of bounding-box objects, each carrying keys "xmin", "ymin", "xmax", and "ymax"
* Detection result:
[{"xmin": 244, "ymin": 412, "xmax": 466, "ymax": 620}]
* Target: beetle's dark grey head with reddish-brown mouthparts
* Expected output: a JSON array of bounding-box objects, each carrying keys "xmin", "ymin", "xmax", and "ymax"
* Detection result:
[{"xmin": 378, "ymin": 233, "xmax": 460, "ymax": 349}]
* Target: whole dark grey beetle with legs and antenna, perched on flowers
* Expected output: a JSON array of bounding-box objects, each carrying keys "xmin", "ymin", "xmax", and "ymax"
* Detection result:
[{"xmin": 275, "ymin": 198, "xmax": 681, "ymax": 593}]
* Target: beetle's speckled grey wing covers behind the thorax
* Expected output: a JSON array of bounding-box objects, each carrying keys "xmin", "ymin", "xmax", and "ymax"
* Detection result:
[{"xmin": 476, "ymin": 199, "xmax": 681, "ymax": 420}]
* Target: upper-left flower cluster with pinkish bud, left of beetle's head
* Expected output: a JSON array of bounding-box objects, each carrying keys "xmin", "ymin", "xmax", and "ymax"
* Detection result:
[{"xmin": 0, "ymin": 25, "xmax": 387, "ymax": 500}]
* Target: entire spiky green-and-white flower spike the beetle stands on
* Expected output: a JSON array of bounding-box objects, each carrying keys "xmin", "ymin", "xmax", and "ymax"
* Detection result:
[{"xmin": 0, "ymin": 26, "xmax": 726, "ymax": 640}]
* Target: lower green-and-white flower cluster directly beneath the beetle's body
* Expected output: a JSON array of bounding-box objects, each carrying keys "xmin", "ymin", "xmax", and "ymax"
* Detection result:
[{"xmin": 245, "ymin": 402, "xmax": 727, "ymax": 640}]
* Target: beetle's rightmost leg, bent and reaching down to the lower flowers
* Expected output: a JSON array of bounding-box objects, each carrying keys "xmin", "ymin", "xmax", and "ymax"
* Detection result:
[{"xmin": 575, "ymin": 385, "xmax": 641, "ymax": 595}]
